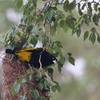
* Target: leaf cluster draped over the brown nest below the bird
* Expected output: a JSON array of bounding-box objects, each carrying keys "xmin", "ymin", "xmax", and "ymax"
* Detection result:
[{"xmin": 11, "ymin": 68, "xmax": 61, "ymax": 100}]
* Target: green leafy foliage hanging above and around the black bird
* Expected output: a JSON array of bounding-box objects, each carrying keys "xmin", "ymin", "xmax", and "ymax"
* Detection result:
[{"xmin": 2, "ymin": 0, "xmax": 100, "ymax": 100}]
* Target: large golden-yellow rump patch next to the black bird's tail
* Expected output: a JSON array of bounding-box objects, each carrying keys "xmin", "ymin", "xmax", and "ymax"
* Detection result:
[{"xmin": 15, "ymin": 50, "xmax": 32, "ymax": 62}]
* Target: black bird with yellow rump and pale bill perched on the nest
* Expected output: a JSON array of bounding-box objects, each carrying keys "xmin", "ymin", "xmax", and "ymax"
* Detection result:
[{"xmin": 5, "ymin": 48, "xmax": 57, "ymax": 68}]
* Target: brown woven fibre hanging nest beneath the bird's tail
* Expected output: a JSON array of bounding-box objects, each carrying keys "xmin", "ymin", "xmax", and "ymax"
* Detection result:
[{"xmin": 2, "ymin": 54, "xmax": 49, "ymax": 100}]
